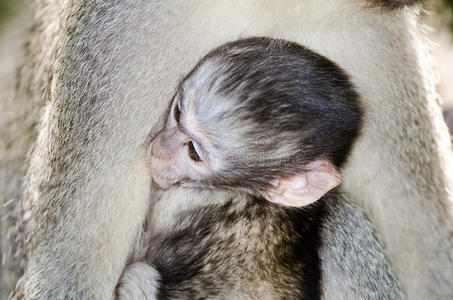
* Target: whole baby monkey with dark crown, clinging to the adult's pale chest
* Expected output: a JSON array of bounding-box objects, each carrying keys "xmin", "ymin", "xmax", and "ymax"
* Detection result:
[{"xmin": 117, "ymin": 38, "xmax": 404, "ymax": 299}]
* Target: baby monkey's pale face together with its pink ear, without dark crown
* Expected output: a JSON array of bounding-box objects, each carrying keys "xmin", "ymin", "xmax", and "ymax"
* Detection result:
[{"xmin": 150, "ymin": 84, "xmax": 340, "ymax": 206}]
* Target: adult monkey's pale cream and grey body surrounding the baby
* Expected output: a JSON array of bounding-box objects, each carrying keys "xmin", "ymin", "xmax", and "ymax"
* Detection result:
[{"xmin": 2, "ymin": 0, "xmax": 453, "ymax": 299}]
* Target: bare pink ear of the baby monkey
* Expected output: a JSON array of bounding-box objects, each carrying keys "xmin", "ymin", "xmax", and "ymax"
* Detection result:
[{"xmin": 265, "ymin": 160, "xmax": 341, "ymax": 206}]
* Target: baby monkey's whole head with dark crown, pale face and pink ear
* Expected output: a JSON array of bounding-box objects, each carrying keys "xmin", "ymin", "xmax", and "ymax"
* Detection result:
[{"xmin": 151, "ymin": 38, "xmax": 361, "ymax": 206}]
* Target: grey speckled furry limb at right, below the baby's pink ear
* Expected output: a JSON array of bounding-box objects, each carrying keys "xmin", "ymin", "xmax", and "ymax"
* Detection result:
[{"xmin": 320, "ymin": 195, "xmax": 406, "ymax": 299}]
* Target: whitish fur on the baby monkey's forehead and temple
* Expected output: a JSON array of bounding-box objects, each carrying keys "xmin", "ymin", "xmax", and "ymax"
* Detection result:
[{"xmin": 181, "ymin": 58, "xmax": 300, "ymax": 173}]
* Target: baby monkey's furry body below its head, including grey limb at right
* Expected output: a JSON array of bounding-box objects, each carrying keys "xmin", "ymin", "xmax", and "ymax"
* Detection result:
[{"xmin": 118, "ymin": 188, "xmax": 406, "ymax": 300}]
